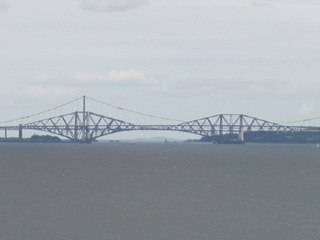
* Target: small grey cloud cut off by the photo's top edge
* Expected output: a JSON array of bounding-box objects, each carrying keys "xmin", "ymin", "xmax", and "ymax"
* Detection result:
[{"xmin": 80, "ymin": 0, "xmax": 148, "ymax": 12}]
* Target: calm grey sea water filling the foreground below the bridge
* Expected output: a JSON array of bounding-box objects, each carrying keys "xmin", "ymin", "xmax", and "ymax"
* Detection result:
[{"xmin": 0, "ymin": 143, "xmax": 320, "ymax": 240}]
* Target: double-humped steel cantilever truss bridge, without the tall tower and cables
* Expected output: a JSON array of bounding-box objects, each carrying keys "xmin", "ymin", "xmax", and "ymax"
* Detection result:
[{"xmin": 20, "ymin": 111, "xmax": 320, "ymax": 143}]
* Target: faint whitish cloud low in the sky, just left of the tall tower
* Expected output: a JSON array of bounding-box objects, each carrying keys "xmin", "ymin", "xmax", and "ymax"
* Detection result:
[{"xmin": 22, "ymin": 85, "xmax": 77, "ymax": 100}]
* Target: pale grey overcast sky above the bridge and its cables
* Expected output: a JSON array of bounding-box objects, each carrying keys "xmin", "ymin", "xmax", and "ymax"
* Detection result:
[{"xmin": 0, "ymin": 0, "xmax": 320, "ymax": 135}]
